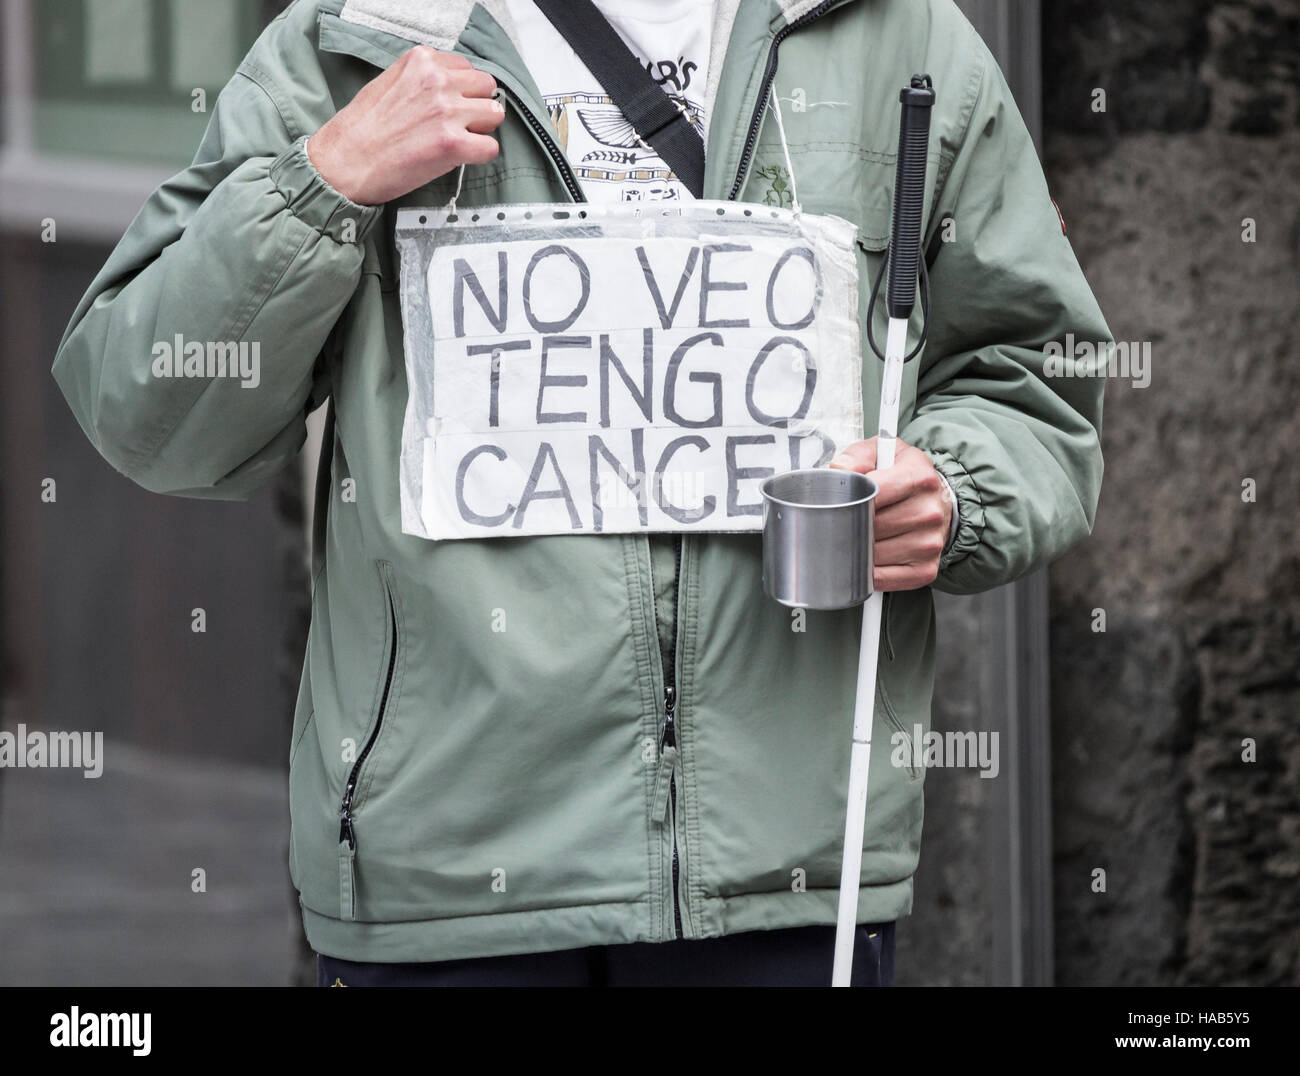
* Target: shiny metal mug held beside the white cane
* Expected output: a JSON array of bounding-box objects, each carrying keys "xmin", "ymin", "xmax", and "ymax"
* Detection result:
[{"xmin": 761, "ymin": 468, "xmax": 879, "ymax": 609}]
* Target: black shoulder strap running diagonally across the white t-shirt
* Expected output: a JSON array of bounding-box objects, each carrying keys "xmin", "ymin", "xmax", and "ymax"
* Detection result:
[{"xmin": 536, "ymin": 0, "xmax": 705, "ymax": 198}]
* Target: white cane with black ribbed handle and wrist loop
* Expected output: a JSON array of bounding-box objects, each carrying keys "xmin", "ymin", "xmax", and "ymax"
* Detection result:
[{"xmin": 831, "ymin": 75, "xmax": 935, "ymax": 986}]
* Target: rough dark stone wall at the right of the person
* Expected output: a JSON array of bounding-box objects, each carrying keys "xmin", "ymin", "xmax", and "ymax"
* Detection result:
[{"xmin": 1043, "ymin": 0, "xmax": 1300, "ymax": 985}]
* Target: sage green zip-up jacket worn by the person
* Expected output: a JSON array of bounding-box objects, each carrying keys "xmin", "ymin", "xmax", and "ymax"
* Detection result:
[{"xmin": 53, "ymin": 0, "xmax": 1110, "ymax": 960}]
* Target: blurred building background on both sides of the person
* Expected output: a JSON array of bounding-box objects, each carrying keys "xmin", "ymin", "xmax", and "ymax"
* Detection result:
[{"xmin": 0, "ymin": 0, "xmax": 1300, "ymax": 985}]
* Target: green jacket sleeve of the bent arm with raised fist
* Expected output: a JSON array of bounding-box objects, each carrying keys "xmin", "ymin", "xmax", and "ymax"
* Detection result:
[{"xmin": 53, "ymin": 43, "xmax": 380, "ymax": 499}]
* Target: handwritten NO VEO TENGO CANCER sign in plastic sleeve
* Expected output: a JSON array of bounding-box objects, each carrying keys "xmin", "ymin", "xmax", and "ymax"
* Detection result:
[{"xmin": 397, "ymin": 201, "xmax": 862, "ymax": 539}]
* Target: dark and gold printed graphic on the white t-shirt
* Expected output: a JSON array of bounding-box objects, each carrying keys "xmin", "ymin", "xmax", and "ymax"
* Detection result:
[{"xmin": 543, "ymin": 57, "xmax": 703, "ymax": 201}]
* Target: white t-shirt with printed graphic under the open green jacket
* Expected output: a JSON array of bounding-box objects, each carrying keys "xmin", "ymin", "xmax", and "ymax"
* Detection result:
[{"xmin": 508, "ymin": 0, "xmax": 714, "ymax": 201}]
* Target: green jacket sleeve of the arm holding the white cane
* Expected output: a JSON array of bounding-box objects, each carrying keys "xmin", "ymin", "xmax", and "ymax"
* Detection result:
[{"xmin": 900, "ymin": 34, "xmax": 1110, "ymax": 594}]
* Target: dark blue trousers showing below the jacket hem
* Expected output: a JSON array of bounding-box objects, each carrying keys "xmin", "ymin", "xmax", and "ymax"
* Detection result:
[{"xmin": 316, "ymin": 923, "xmax": 894, "ymax": 986}]
